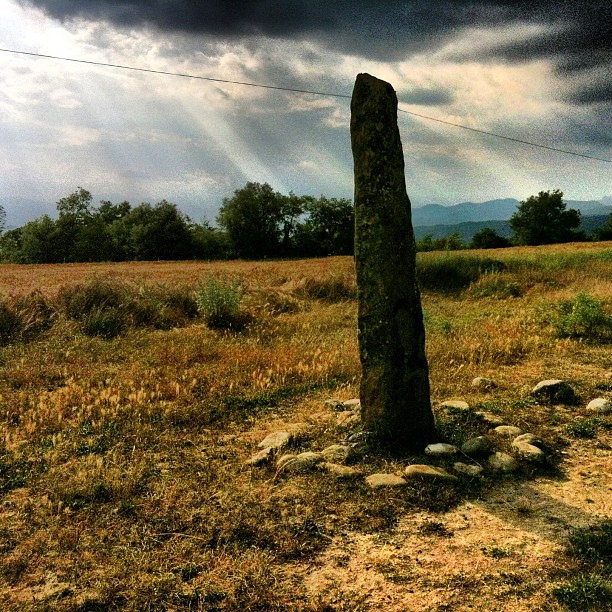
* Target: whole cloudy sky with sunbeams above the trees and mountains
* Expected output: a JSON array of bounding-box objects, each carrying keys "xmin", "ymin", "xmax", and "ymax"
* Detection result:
[{"xmin": 0, "ymin": 0, "xmax": 612, "ymax": 222}]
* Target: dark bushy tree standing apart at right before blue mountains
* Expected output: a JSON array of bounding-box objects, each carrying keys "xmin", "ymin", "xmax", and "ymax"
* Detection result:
[{"xmin": 510, "ymin": 189, "xmax": 584, "ymax": 245}]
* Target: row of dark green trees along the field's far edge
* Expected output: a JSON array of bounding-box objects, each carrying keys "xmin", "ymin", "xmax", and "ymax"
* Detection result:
[{"xmin": 0, "ymin": 182, "xmax": 612, "ymax": 263}]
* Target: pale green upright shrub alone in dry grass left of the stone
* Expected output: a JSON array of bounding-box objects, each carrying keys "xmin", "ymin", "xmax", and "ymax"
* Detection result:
[{"xmin": 195, "ymin": 276, "xmax": 245, "ymax": 329}]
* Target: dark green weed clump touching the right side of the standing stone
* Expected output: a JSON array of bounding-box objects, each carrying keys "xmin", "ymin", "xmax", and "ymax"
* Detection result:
[{"xmin": 416, "ymin": 255, "xmax": 506, "ymax": 292}]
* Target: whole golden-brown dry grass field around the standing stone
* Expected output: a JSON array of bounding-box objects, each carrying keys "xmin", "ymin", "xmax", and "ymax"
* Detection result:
[{"xmin": 0, "ymin": 243, "xmax": 612, "ymax": 612}]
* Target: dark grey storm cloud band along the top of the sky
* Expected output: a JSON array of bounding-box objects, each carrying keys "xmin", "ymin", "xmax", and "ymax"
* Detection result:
[{"xmin": 22, "ymin": 0, "xmax": 612, "ymax": 104}]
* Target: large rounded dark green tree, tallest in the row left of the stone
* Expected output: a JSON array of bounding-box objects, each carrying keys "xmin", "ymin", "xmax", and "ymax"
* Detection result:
[{"xmin": 217, "ymin": 183, "xmax": 285, "ymax": 259}]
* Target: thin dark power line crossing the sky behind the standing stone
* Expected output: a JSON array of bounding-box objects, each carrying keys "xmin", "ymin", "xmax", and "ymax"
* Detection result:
[{"xmin": 0, "ymin": 48, "xmax": 612, "ymax": 163}]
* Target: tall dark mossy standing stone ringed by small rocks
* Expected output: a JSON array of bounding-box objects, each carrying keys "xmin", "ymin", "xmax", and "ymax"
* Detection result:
[{"xmin": 351, "ymin": 74, "xmax": 435, "ymax": 449}]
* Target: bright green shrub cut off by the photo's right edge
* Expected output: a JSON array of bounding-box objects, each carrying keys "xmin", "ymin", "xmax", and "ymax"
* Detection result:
[{"xmin": 552, "ymin": 292, "xmax": 612, "ymax": 342}]
